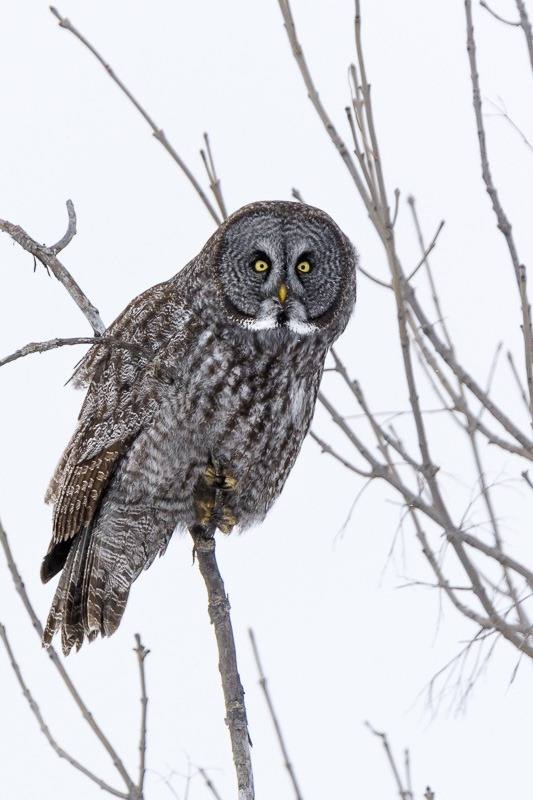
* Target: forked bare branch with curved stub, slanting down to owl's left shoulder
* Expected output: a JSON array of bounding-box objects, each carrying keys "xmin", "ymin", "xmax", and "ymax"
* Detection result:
[{"xmin": 0, "ymin": 200, "xmax": 105, "ymax": 336}]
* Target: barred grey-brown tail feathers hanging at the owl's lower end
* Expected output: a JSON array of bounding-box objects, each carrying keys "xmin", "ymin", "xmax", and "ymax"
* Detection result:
[{"xmin": 42, "ymin": 525, "xmax": 131, "ymax": 655}]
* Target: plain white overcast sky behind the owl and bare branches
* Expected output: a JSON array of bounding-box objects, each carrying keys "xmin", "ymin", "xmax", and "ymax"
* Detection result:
[{"xmin": 0, "ymin": 0, "xmax": 533, "ymax": 800}]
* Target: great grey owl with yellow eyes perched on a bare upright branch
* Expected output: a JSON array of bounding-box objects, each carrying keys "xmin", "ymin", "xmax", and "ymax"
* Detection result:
[{"xmin": 41, "ymin": 202, "xmax": 357, "ymax": 654}]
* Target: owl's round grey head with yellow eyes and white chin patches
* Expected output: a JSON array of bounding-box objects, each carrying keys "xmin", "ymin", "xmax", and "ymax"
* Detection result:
[{"xmin": 211, "ymin": 202, "xmax": 357, "ymax": 338}]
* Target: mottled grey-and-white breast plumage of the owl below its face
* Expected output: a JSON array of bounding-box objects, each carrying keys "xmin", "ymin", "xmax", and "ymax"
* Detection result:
[{"xmin": 182, "ymin": 334, "xmax": 325, "ymax": 528}]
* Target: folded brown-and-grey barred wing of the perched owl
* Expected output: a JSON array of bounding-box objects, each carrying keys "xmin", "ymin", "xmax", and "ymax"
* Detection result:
[{"xmin": 41, "ymin": 284, "xmax": 197, "ymax": 582}]
